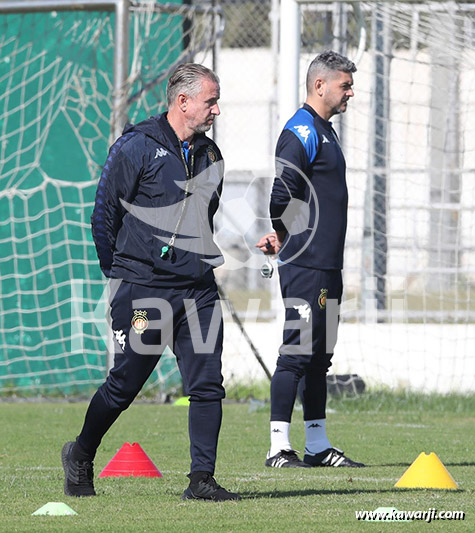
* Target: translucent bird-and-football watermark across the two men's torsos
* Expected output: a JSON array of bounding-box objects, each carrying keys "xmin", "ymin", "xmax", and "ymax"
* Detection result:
[{"xmin": 120, "ymin": 156, "xmax": 319, "ymax": 270}]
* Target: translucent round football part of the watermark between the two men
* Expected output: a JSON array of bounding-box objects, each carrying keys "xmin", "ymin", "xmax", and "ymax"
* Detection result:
[{"xmin": 216, "ymin": 158, "xmax": 319, "ymax": 270}]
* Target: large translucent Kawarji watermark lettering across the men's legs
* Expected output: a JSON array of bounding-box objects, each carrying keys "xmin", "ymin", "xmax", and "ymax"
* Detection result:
[{"xmin": 70, "ymin": 279, "xmax": 407, "ymax": 354}]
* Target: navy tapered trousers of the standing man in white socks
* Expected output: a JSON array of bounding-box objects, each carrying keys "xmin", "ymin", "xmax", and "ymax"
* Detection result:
[{"xmin": 271, "ymin": 264, "xmax": 343, "ymax": 422}]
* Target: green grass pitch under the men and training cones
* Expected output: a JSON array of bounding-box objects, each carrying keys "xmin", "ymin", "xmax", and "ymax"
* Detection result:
[{"xmin": 0, "ymin": 394, "xmax": 475, "ymax": 533}]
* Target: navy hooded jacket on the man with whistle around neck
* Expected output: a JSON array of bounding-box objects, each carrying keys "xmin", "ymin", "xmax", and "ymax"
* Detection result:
[{"xmin": 91, "ymin": 113, "xmax": 223, "ymax": 287}]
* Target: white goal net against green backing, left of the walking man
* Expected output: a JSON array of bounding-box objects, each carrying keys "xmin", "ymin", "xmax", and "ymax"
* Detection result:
[{"xmin": 0, "ymin": 2, "xmax": 216, "ymax": 395}]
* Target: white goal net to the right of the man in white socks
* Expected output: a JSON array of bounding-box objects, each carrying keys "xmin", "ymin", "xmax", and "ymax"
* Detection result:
[{"xmin": 300, "ymin": 1, "xmax": 475, "ymax": 392}]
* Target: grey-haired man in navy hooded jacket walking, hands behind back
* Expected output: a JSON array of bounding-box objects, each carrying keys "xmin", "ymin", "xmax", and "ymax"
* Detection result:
[{"xmin": 62, "ymin": 63, "xmax": 240, "ymax": 501}]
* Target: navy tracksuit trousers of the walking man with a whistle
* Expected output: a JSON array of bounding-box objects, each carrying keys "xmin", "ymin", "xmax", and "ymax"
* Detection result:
[{"xmin": 77, "ymin": 281, "xmax": 225, "ymax": 474}]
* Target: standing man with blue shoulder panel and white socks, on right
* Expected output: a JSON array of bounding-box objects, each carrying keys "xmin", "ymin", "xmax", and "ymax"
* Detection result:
[{"xmin": 256, "ymin": 51, "xmax": 364, "ymax": 468}]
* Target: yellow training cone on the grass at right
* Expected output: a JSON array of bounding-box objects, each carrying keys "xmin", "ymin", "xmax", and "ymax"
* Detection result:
[{"xmin": 394, "ymin": 452, "xmax": 458, "ymax": 489}]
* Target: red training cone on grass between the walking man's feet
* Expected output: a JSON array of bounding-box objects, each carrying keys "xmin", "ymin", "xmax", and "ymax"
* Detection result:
[{"xmin": 99, "ymin": 442, "xmax": 163, "ymax": 477}]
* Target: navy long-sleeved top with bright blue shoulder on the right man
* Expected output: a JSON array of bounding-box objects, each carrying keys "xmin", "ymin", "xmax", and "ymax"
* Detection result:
[{"xmin": 270, "ymin": 104, "xmax": 348, "ymax": 270}]
